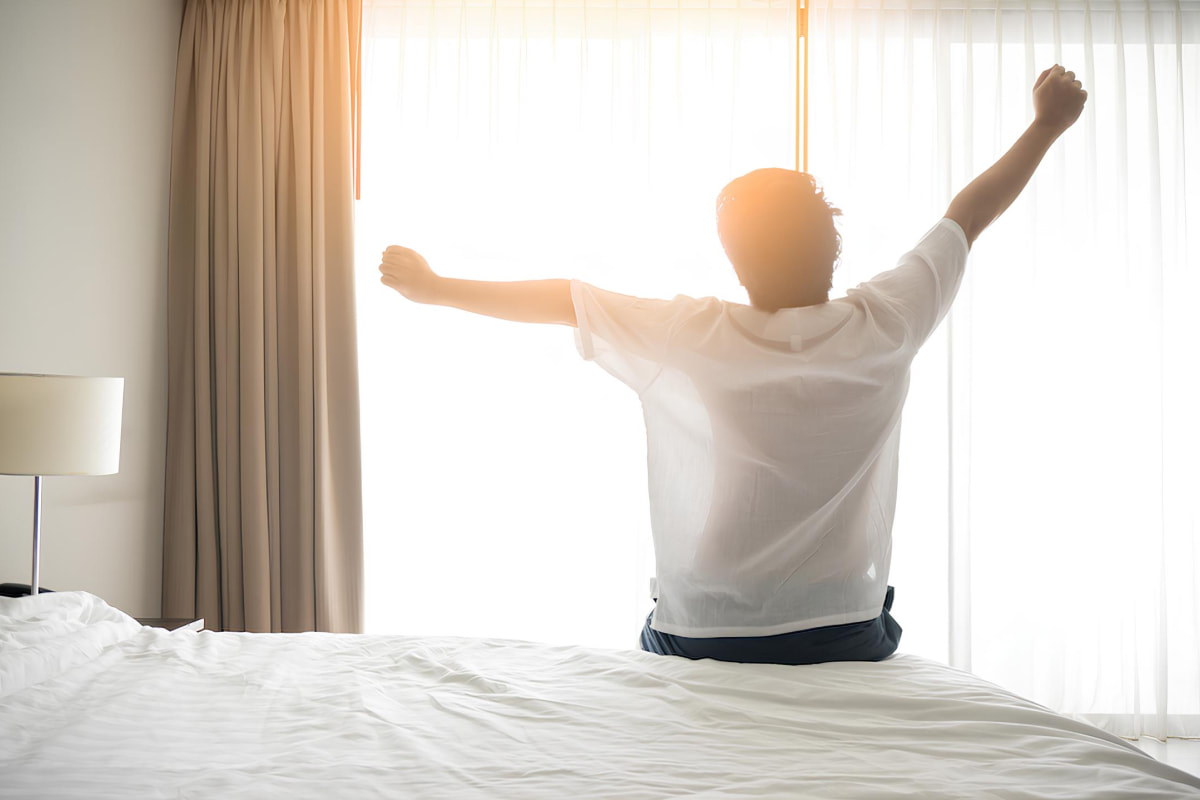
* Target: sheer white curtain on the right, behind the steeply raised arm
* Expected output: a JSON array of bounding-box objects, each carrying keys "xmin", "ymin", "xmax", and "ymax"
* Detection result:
[{"xmin": 810, "ymin": 0, "xmax": 1200, "ymax": 736}]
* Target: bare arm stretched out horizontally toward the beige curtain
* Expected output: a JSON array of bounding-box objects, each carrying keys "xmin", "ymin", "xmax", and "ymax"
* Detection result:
[{"xmin": 379, "ymin": 245, "xmax": 577, "ymax": 327}]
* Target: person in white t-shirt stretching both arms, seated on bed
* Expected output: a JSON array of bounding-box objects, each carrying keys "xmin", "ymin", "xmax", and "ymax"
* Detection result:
[{"xmin": 379, "ymin": 65, "xmax": 1087, "ymax": 664}]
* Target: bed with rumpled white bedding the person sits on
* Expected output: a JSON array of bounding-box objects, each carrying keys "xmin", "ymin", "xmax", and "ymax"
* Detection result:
[{"xmin": 0, "ymin": 593, "xmax": 1200, "ymax": 800}]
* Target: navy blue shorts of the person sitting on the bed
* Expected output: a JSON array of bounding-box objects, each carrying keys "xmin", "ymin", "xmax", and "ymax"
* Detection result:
[{"xmin": 642, "ymin": 587, "xmax": 901, "ymax": 664}]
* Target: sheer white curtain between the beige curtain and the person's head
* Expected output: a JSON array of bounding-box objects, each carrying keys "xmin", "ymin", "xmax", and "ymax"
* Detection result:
[{"xmin": 356, "ymin": 0, "xmax": 794, "ymax": 646}]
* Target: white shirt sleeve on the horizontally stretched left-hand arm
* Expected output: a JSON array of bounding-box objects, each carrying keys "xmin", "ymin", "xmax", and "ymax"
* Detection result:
[{"xmin": 571, "ymin": 281, "xmax": 700, "ymax": 395}]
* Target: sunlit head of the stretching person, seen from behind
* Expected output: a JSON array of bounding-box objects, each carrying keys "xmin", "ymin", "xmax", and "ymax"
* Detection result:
[{"xmin": 716, "ymin": 168, "xmax": 841, "ymax": 311}]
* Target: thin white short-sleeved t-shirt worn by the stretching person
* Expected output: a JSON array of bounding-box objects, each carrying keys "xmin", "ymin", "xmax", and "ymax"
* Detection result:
[{"xmin": 571, "ymin": 219, "xmax": 967, "ymax": 637}]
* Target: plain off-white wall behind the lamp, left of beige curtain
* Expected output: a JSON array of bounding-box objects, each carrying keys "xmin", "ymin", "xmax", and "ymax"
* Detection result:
[{"xmin": 0, "ymin": 0, "xmax": 182, "ymax": 616}]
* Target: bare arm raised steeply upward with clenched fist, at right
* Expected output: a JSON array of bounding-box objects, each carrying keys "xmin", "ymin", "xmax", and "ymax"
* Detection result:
[{"xmin": 946, "ymin": 64, "xmax": 1087, "ymax": 243}]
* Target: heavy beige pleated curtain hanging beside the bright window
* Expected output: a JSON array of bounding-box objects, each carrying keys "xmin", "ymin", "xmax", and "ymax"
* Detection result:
[{"xmin": 163, "ymin": 0, "xmax": 362, "ymax": 632}]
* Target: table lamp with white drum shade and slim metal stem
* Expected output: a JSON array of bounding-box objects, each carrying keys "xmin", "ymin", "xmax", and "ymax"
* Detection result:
[{"xmin": 0, "ymin": 372, "xmax": 125, "ymax": 595}]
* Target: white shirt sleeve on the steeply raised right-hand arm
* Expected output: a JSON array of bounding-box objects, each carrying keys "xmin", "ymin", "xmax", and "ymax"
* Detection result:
[{"xmin": 852, "ymin": 219, "xmax": 970, "ymax": 347}]
